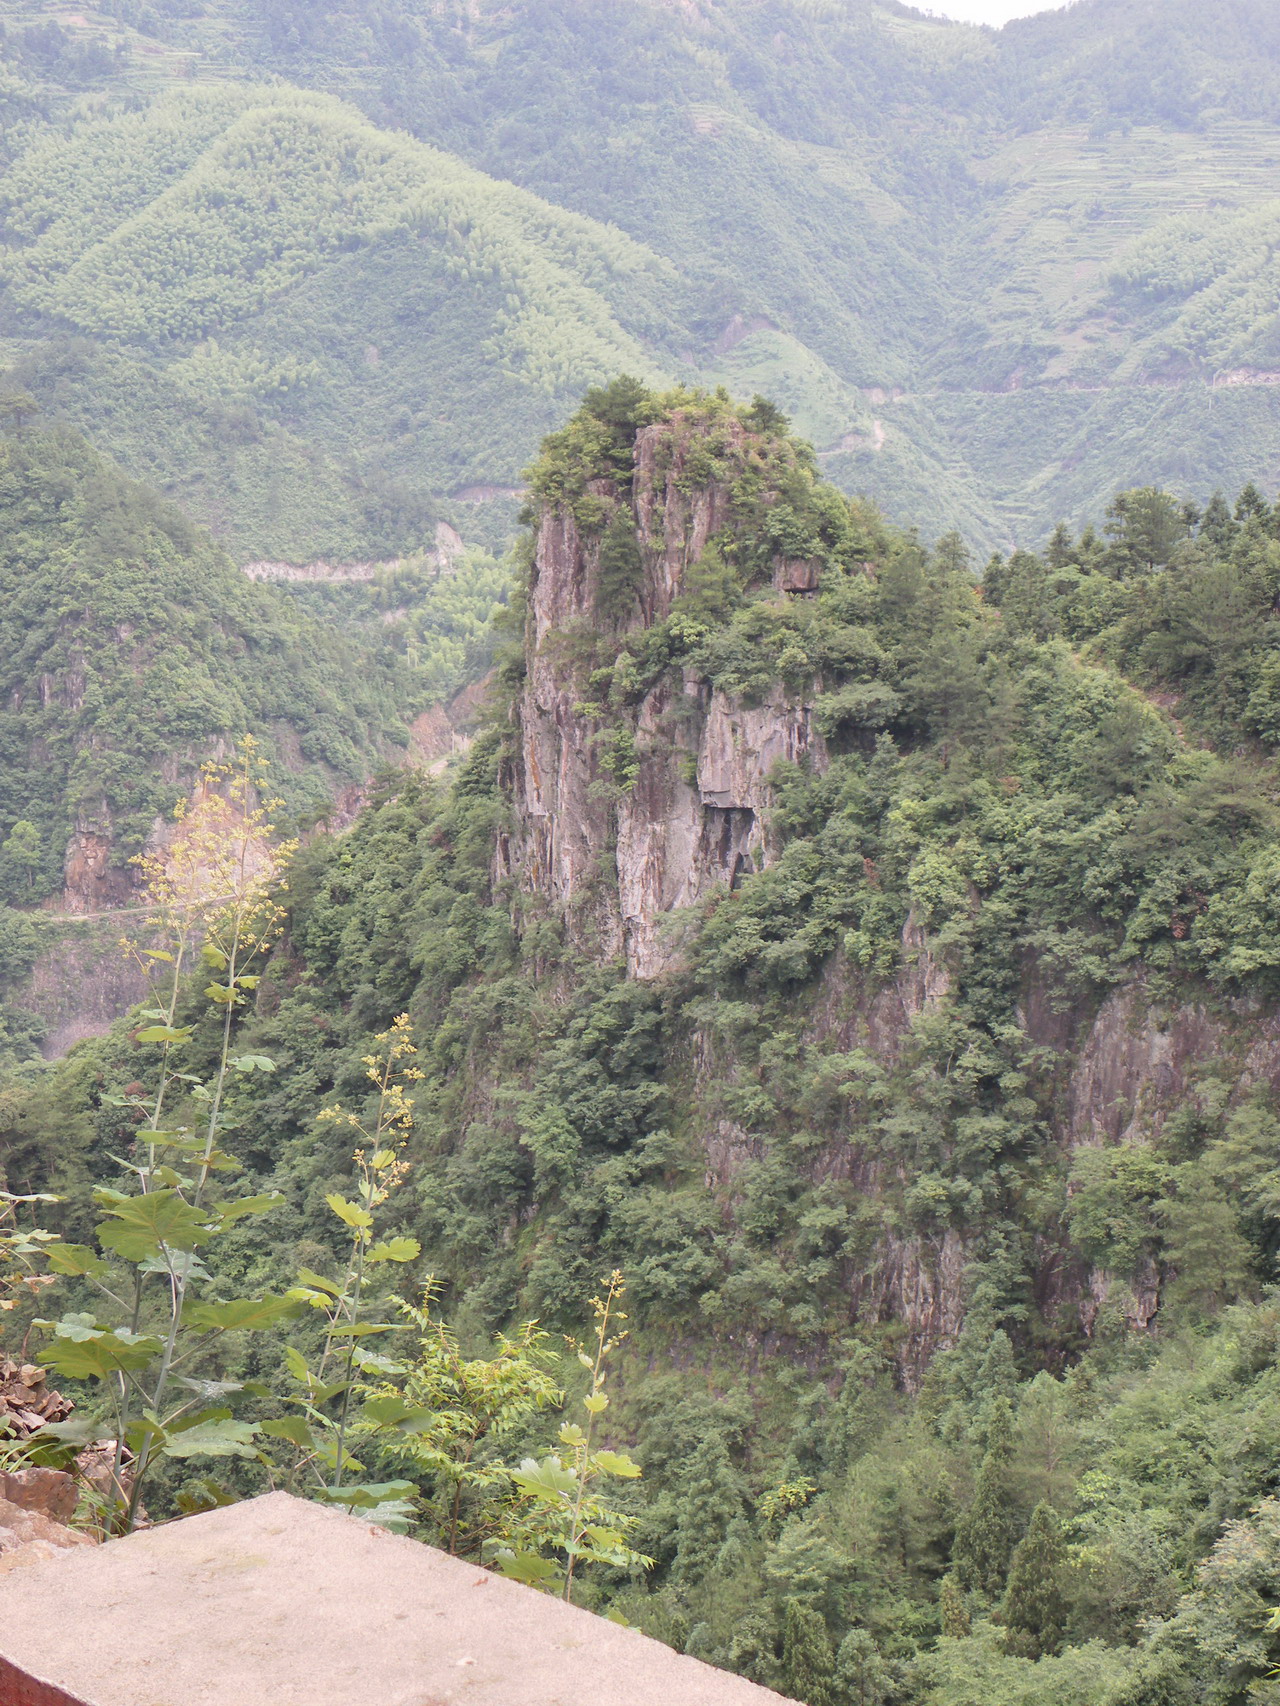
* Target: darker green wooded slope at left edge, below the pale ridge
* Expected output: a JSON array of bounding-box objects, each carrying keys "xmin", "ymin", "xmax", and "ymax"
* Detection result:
[{"xmin": 0, "ymin": 428, "xmax": 416, "ymax": 904}]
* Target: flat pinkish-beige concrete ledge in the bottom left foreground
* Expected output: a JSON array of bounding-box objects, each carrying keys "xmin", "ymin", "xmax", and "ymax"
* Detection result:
[{"xmin": 0, "ymin": 1493, "xmax": 798, "ymax": 1706}]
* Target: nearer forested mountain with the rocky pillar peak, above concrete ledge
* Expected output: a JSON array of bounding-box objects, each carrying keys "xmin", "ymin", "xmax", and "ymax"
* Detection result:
[{"xmin": 0, "ymin": 380, "xmax": 1280, "ymax": 1706}]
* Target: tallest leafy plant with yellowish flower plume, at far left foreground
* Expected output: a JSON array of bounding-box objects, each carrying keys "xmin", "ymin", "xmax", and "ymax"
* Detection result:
[{"xmin": 34, "ymin": 737, "xmax": 299, "ymax": 1530}]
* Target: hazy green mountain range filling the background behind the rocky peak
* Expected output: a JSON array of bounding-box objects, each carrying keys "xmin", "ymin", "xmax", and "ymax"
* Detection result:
[{"xmin": 0, "ymin": 0, "xmax": 1280, "ymax": 561}]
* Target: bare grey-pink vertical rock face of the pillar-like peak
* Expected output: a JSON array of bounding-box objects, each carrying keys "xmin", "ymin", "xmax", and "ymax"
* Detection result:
[{"xmin": 507, "ymin": 416, "xmax": 826, "ymax": 978}]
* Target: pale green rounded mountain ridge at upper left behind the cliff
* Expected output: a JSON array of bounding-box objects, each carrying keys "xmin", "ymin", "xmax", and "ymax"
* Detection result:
[{"xmin": 0, "ymin": 89, "xmax": 682, "ymax": 561}]
